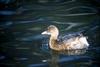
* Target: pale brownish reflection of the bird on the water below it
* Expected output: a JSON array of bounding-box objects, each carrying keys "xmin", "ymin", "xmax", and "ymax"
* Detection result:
[{"xmin": 48, "ymin": 49, "xmax": 86, "ymax": 67}]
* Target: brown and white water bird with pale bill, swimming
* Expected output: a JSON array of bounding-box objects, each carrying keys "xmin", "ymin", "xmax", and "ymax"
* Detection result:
[{"xmin": 42, "ymin": 25, "xmax": 89, "ymax": 50}]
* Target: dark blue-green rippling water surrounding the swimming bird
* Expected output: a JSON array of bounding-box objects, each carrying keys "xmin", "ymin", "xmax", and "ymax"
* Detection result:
[{"xmin": 0, "ymin": 0, "xmax": 100, "ymax": 67}]
